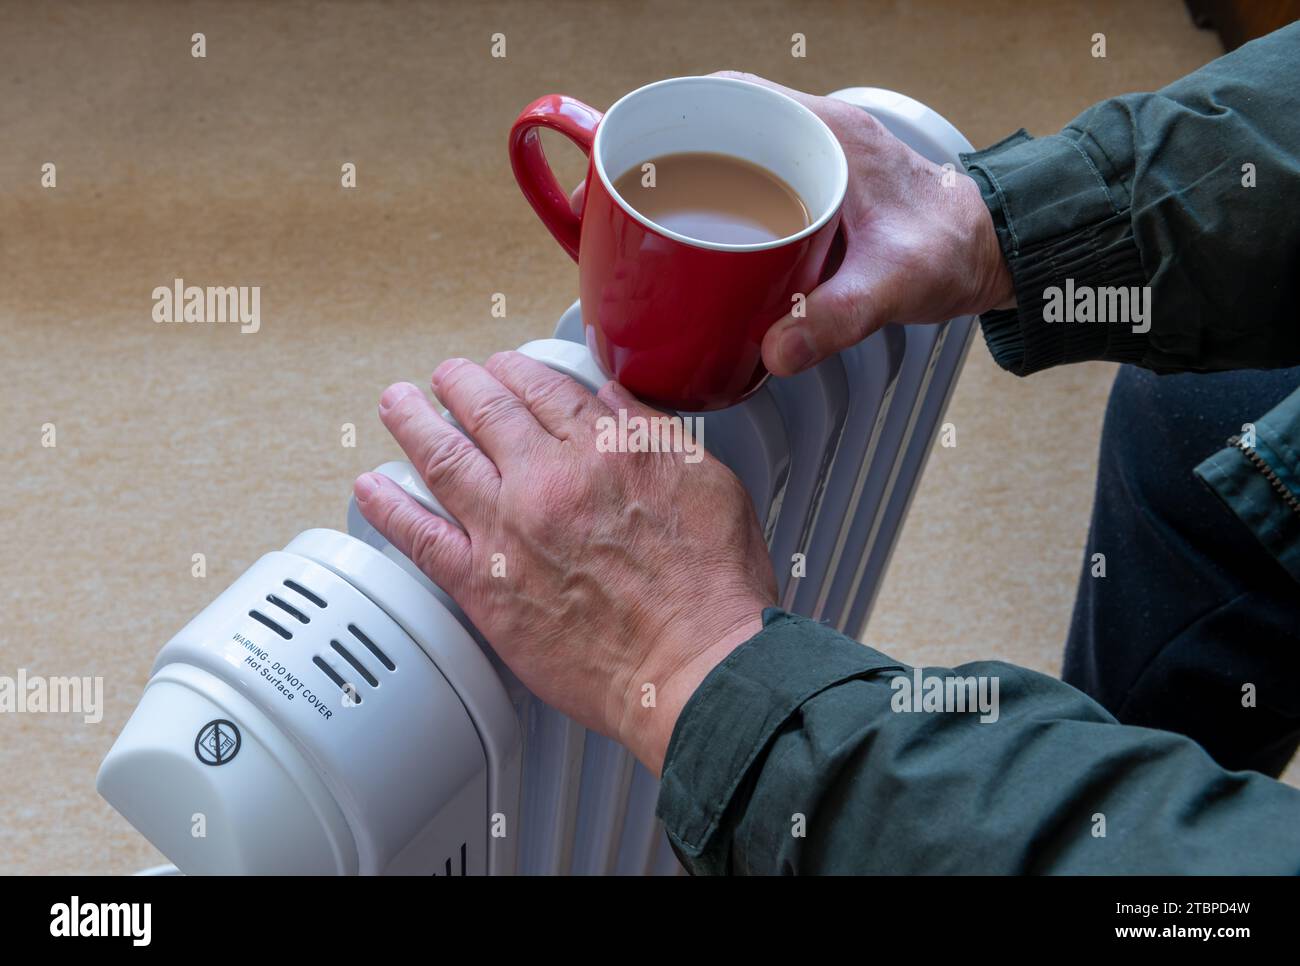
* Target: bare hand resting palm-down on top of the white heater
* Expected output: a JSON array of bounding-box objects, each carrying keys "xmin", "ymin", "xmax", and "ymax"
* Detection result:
[{"xmin": 355, "ymin": 352, "xmax": 776, "ymax": 774}]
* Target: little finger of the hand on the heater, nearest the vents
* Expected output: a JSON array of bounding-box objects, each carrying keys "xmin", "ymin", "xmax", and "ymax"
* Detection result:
[{"xmin": 352, "ymin": 473, "xmax": 471, "ymax": 597}]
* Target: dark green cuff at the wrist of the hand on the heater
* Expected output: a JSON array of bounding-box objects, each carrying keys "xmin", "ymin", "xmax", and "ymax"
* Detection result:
[{"xmin": 657, "ymin": 607, "xmax": 902, "ymax": 875}]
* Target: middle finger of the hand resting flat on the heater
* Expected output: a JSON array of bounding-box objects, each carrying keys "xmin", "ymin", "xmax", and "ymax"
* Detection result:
[{"xmin": 429, "ymin": 359, "xmax": 545, "ymax": 470}]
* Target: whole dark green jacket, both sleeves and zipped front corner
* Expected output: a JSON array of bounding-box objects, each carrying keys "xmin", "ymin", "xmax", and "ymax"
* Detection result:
[{"xmin": 659, "ymin": 25, "xmax": 1300, "ymax": 874}]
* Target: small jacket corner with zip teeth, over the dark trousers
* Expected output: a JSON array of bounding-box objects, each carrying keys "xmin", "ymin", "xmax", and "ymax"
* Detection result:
[{"xmin": 1195, "ymin": 423, "xmax": 1300, "ymax": 581}]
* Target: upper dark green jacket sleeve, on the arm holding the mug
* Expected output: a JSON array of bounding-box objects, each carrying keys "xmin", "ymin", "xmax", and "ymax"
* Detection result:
[{"xmin": 962, "ymin": 23, "xmax": 1300, "ymax": 376}]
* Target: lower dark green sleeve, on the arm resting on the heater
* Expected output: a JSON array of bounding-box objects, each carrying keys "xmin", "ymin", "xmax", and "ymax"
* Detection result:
[{"xmin": 659, "ymin": 608, "xmax": 1300, "ymax": 874}]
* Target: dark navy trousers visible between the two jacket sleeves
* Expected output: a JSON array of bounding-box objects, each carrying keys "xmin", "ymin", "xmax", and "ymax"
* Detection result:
[{"xmin": 1062, "ymin": 365, "xmax": 1300, "ymax": 775}]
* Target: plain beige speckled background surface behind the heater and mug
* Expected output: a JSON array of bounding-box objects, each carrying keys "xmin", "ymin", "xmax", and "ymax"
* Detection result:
[{"xmin": 0, "ymin": 0, "xmax": 1279, "ymax": 872}]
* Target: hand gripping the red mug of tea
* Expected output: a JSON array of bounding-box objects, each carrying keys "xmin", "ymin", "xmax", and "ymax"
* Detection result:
[{"xmin": 571, "ymin": 70, "xmax": 1014, "ymax": 376}]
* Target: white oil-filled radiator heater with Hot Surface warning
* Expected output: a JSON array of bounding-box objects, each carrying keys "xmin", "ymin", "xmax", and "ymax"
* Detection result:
[{"xmin": 98, "ymin": 88, "xmax": 974, "ymax": 875}]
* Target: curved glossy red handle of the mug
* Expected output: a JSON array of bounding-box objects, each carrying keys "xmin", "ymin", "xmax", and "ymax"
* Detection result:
[{"xmin": 510, "ymin": 94, "xmax": 602, "ymax": 261}]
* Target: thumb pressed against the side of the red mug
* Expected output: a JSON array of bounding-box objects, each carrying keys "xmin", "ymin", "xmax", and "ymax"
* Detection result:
[{"xmin": 763, "ymin": 249, "xmax": 893, "ymax": 376}]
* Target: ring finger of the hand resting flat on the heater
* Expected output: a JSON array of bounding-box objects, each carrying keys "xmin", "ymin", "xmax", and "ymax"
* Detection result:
[{"xmin": 379, "ymin": 382, "xmax": 501, "ymax": 525}]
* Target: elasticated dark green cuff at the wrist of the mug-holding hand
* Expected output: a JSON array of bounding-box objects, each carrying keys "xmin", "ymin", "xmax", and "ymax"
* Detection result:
[{"xmin": 962, "ymin": 129, "xmax": 1151, "ymax": 376}]
